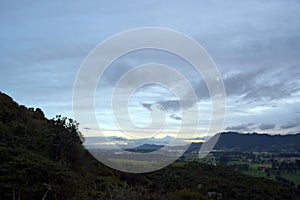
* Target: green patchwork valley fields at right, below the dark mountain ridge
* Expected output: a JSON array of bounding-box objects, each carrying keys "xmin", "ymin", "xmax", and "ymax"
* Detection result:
[{"xmin": 181, "ymin": 151, "xmax": 300, "ymax": 188}]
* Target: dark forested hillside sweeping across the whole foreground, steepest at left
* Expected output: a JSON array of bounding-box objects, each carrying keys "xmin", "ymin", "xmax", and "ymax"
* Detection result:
[{"xmin": 0, "ymin": 93, "xmax": 300, "ymax": 200}]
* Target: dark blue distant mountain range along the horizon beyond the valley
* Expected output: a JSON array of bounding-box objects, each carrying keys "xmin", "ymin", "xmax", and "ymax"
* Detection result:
[{"xmin": 122, "ymin": 132, "xmax": 300, "ymax": 153}]
